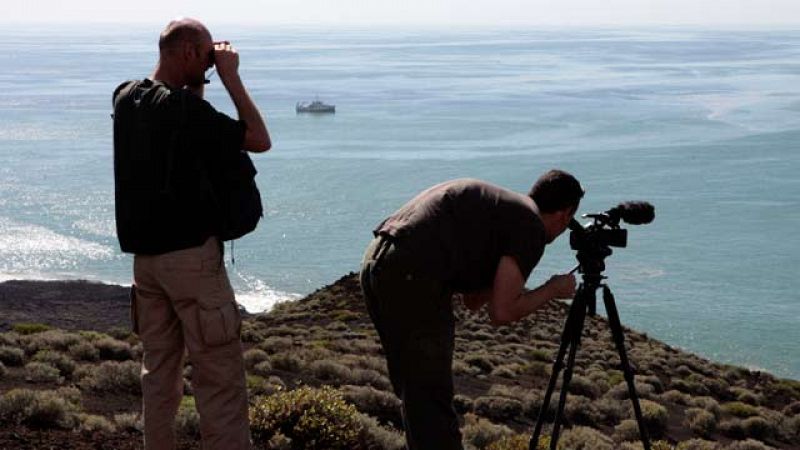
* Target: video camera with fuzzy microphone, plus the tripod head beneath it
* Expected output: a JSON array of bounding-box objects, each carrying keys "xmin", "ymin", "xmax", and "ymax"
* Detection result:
[{"xmin": 569, "ymin": 202, "xmax": 655, "ymax": 316}]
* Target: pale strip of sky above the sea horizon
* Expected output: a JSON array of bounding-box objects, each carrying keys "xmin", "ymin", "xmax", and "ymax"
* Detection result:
[{"xmin": 0, "ymin": 0, "xmax": 800, "ymax": 27}]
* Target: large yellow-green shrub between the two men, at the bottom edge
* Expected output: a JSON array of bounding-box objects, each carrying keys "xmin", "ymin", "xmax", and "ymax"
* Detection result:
[{"xmin": 250, "ymin": 387, "xmax": 363, "ymax": 450}]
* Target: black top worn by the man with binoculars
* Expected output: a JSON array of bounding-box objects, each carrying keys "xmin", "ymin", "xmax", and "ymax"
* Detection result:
[{"xmin": 113, "ymin": 79, "xmax": 246, "ymax": 255}]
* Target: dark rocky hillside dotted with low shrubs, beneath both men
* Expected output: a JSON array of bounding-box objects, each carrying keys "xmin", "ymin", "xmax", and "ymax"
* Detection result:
[{"xmin": 0, "ymin": 275, "xmax": 800, "ymax": 450}]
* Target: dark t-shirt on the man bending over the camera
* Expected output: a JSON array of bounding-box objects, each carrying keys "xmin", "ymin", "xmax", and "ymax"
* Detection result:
[{"xmin": 374, "ymin": 179, "xmax": 547, "ymax": 292}]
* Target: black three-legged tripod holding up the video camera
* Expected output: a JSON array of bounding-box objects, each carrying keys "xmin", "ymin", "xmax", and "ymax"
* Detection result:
[{"xmin": 528, "ymin": 246, "xmax": 650, "ymax": 450}]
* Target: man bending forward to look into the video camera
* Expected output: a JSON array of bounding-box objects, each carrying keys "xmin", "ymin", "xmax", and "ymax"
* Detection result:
[{"xmin": 361, "ymin": 170, "xmax": 583, "ymax": 450}]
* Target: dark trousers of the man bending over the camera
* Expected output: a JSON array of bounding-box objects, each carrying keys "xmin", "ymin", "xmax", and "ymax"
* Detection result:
[{"xmin": 361, "ymin": 237, "xmax": 463, "ymax": 450}]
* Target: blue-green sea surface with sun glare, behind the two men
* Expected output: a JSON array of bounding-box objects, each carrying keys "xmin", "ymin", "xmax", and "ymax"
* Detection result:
[{"xmin": 0, "ymin": 25, "xmax": 800, "ymax": 379}]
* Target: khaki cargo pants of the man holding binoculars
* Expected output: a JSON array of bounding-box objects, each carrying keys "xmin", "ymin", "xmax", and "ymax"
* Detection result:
[{"xmin": 131, "ymin": 238, "xmax": 251, "ymax": 450}]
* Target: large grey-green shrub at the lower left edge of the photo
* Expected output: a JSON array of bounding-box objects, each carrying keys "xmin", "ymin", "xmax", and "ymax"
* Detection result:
[{"xmin": 0, "ymin": 389, "xmax": 78, "ymax": 428}]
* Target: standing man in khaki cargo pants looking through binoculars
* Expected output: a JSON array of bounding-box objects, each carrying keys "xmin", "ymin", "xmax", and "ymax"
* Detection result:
[{"xmin": 113, "ymin": 18, "xmax": 271, "ymax": 450}]
